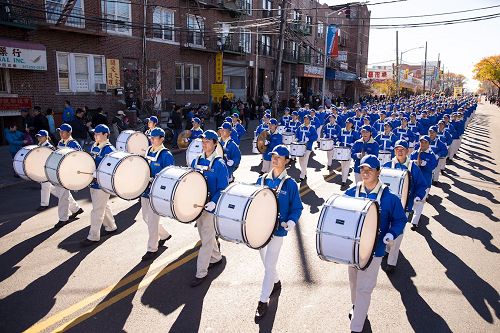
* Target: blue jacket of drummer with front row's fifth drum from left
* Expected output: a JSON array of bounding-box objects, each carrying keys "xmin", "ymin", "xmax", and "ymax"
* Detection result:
[{"xmin": 256, "ymin": 172, "xmax": 304, "ymax": 237}]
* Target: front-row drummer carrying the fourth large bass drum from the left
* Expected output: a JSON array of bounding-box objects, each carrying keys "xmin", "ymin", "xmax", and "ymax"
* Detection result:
[{"xmin": 191, "ymin": 130, "xmax": 228, "ymax": 287}]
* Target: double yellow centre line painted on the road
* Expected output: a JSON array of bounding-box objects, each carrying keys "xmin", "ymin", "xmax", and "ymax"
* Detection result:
[{"xmin": 25, "ymin": 163, "xmax": 340, "ymax": 333}]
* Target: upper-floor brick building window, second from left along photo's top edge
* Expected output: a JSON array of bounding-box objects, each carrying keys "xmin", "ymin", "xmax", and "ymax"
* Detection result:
[{"xmin": 101, "ymin": 0, "xmax": 132, "ymax": 35}]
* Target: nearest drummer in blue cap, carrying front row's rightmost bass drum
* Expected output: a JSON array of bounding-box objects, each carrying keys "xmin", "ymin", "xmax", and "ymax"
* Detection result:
[{"xmin": 345, "ymin": 155, "xmax": 406, "ymax": 332}]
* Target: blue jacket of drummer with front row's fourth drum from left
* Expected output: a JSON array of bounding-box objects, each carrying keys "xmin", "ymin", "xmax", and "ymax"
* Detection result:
[{"xmin": 191, "ymin": 152, "xmax": 229, "ymax": 213}]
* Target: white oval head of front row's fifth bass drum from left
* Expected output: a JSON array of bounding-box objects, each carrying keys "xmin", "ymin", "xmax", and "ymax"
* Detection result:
[{"xmin": 245, "ymin": 188, "xmax": 278, "ymax": 249}]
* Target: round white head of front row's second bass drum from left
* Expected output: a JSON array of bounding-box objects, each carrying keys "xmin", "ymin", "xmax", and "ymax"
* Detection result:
[{"xmin": 57, "ymin": 148, "xmax": 96, "ymax": 191}]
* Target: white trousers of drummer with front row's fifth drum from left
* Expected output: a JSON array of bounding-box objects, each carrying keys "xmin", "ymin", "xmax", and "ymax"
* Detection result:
[{"xmin": 259, "ymin": 236, "xmax": 284, "ymax": 303}]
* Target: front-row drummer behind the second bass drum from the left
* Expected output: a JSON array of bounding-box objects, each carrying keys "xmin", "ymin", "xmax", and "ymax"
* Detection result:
[{"xmin": 54, "ymin": 124, "xmax": 83, "ymax": 229}]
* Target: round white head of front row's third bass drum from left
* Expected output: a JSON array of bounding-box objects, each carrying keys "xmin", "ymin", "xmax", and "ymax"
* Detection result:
[{"xmin": 113, "ymin": 155, "xmax": 150, "ymax": 200}]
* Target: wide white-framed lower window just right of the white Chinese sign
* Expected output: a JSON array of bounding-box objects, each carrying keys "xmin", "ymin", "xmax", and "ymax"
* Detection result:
[{"xmin": 56, "ymin": 52, "xmax": 106, "ymax": 92}]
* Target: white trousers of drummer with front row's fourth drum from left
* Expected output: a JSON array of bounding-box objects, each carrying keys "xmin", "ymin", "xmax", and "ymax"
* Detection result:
[{"xmin": 196, "ymin": 210, "xmax": 222, "ymax": 279}]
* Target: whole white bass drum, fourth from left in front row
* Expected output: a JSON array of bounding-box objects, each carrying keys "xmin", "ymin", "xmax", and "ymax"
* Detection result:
[{"xmin": 149, "ymin": 165, "xmax": 208, "ymax": 223}]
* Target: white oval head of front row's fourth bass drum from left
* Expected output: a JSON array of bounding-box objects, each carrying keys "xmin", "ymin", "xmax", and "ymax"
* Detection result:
[{"xmin": 173, "ymin": 171, "xmax": 208, "ymax": 223}]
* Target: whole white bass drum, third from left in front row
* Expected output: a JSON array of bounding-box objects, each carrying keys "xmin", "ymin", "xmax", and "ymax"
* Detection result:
[{"xmin": 96, "ymin": 151, "xmax": 151, "ymax": 200}]
